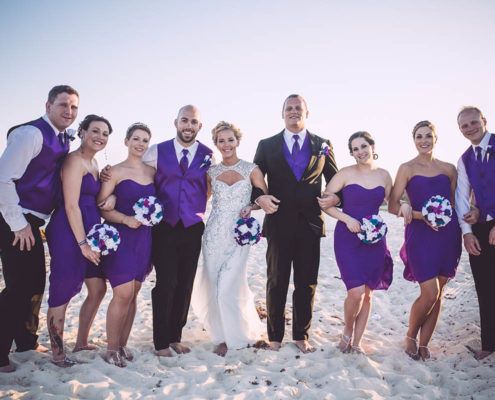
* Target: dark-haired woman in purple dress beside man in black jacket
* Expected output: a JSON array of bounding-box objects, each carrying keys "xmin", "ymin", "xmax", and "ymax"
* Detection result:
[{"xmin": 320, "ymin": 132, "xmax": 393, "ymax": 354}]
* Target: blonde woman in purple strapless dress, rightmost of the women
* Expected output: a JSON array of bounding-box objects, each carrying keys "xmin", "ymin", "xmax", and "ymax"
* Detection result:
[{"xmin": 388, "ymin": 121, "xmax": 461, "ymax": 360}]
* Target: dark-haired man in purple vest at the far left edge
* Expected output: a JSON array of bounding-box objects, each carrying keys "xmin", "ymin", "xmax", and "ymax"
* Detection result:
[{"xmin": 0, "ymin": 85, "xmax": 79, "ymax": 372}]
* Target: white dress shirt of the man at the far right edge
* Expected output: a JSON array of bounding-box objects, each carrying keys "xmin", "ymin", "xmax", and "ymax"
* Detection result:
[{"xmin": 455, "ymin": 132, "xmax": 493, "ymax": 235}]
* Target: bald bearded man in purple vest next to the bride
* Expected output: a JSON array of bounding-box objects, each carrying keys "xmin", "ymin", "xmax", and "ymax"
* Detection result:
[{"xmin": 143, "ymin": 105, "xmax": 212, "ymax": 357}]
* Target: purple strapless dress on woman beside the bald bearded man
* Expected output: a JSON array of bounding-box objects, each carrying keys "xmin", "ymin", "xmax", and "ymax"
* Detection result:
[{"xmin": 102, "ymin": 179, "xmax": 155, "ymax": 287}]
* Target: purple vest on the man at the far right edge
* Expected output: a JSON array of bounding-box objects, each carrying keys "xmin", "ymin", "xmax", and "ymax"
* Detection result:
[{"xmin": 462, "ymin": 134, "xmax": 495, "ymax": 223}]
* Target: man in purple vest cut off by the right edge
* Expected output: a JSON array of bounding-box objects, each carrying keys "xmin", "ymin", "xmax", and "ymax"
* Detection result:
[{"xmin": 455, "ymin": 106, "xmax": 495, "ymax": 360}]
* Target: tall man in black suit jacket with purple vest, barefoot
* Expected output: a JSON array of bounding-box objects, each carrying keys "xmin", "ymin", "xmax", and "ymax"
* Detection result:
[{"xmin": 252, "ymin": 94, "xmax": 337, "ymax": 353}]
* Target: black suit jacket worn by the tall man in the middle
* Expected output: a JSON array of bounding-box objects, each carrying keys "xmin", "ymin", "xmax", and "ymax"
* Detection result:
[{"xmin": 252, "ymin": 131, "xmax": 337, "ymax": 238}]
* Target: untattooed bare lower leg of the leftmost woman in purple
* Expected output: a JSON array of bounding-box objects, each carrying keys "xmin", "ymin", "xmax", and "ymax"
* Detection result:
[{"xmin": 74, "ymin": 278, "xmax": 107, "ymax": 352}]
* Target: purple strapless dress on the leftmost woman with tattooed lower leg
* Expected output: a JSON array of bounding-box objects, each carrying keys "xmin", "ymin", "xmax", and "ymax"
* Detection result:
[{"xmin": 46, "ymin": 173, "xmax": 101, "ymax": 307}]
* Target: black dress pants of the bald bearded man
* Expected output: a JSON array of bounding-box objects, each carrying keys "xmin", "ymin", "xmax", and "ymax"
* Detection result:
[{"xmin": 151, "ymin": 221, "xmax": 205, "ymax": 350}]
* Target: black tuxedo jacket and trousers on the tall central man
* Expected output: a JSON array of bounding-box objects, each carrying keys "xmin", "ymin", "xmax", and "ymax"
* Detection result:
[{"xmin": 253, "ymin": 131, "xmax": 337, "ymax": 342}]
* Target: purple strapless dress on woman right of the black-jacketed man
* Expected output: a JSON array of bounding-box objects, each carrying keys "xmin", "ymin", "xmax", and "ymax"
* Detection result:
[{"xmin": 334, "ymin": 184, "xmax": 393, "ymax": 290}]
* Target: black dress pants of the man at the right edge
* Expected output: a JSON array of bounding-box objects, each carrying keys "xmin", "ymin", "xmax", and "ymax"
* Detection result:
[{"xmin": 469, "ymin": 220, "xmax": 495, "ymax": 351}]
